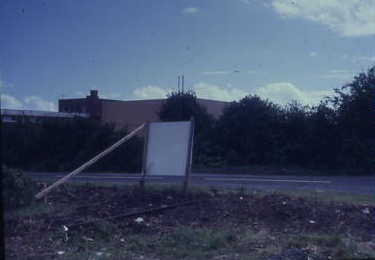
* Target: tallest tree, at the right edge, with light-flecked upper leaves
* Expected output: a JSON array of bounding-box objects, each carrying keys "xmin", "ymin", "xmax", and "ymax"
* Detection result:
[{"xmin": 331, "ymin": 67, "xmax": 375, "ymax": 172}]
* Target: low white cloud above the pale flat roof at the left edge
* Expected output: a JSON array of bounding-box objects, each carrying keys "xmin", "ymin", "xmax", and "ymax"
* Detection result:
[{"xmin": 1, "ymin": 94, "xmax": 57, "ymax": 111}]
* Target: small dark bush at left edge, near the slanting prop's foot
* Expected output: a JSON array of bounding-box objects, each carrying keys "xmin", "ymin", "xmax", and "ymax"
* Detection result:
[{"xmin": 2, "ymin": 166, "xmax": 37, "ymax": 210}]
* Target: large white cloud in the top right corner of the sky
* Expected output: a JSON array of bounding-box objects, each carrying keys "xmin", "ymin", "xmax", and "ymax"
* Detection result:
[{"xmin": 272, "ymin": 0, "xmax": 375, "ymax": 37}]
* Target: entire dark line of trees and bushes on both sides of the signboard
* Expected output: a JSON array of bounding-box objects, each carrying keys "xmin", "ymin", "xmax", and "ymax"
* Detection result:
[{"xmin": 2, "ymin": 67, "xmax": 375, "ymax": 174}]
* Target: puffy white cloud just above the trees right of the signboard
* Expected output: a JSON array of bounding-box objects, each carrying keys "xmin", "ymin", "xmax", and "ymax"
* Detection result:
[{"xmin": 256, "ymin": 82, "xmax": 333, "ymax": 105}]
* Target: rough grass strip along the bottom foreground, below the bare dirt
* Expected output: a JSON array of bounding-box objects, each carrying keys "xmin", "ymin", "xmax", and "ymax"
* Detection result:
[{"xmin": 43, "ymin": 226, "xmax": 375, "ymax": 260}]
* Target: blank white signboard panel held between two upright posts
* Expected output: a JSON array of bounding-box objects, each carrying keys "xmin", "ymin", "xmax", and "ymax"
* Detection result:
[{"xmin": 145, "ymin": 121, "xmax": 192, "ymax": 176}]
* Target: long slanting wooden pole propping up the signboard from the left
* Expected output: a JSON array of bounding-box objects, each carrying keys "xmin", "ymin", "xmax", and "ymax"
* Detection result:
[{"xmin": 35, "ymin": 124, "xmax": 145, "ymax": 199}]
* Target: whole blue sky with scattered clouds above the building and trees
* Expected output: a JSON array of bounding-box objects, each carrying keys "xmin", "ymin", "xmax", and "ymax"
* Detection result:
[{"xmin": 1, "ymin": 0, "xmax": 375, "ymax": 111}]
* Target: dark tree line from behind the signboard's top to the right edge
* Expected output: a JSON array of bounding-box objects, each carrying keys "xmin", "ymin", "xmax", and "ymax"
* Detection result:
[{"xmin": 159, "ymin": 67, "xmax": 375, "ymax": 174}]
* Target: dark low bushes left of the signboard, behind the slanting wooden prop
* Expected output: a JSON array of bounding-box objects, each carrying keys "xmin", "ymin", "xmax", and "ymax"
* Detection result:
[{"xmin": 1, "ymin": 118, "xmax": 143, "ymax": 172}]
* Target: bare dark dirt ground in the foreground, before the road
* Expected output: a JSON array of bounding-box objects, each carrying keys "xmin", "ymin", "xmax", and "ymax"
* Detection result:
[{"xmin": 5, "ymin": 185, "xmax": 374, "ymax": 260}]
